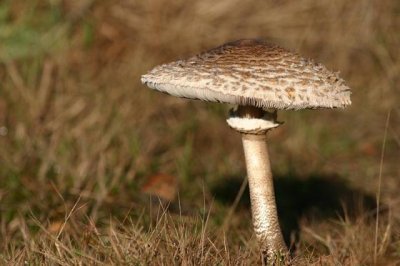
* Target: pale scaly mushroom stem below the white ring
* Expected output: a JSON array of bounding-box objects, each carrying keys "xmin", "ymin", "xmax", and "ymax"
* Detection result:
[{"xmin": 242, "ymin": 134, "xmax": 288, "ymax": 261}]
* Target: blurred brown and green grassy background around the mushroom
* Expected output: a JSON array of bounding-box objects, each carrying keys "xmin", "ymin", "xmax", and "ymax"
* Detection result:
[{"xmin": 0, "ymin": 0, "xmax": 400, "ymax": 265}]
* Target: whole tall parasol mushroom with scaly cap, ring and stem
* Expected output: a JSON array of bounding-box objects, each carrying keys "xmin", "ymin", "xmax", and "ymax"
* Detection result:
[{"xmin": 141, "ymin": 39, "xmax": 351, "ymax": 262}]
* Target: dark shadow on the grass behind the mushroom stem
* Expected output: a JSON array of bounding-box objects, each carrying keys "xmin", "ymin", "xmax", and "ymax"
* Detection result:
[{"xmin": 211, "ymin": 174, "xmax": 376, "ymax": 243}]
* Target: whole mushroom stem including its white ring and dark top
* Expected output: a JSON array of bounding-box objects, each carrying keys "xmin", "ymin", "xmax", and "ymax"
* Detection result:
[{"xmin": 227, "ymin": 106, "xmax": 288, "ymax": 263}]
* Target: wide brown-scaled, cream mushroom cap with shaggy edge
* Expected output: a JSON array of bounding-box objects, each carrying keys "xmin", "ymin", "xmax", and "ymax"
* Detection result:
[{"xmin": 141, "ymin": 39, "xmax": 351, "ymax": 109}]
